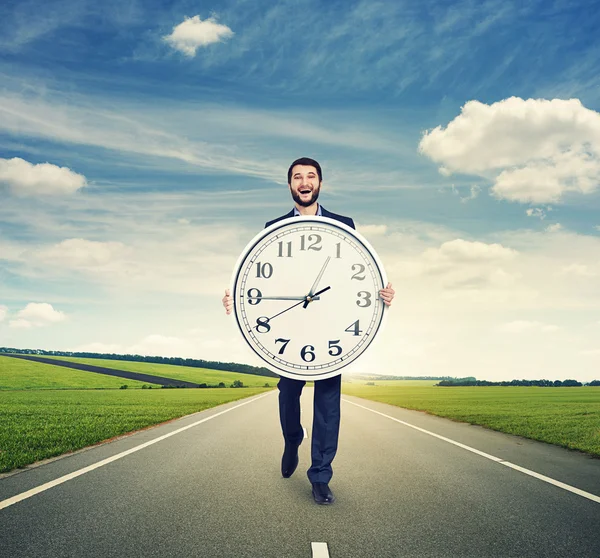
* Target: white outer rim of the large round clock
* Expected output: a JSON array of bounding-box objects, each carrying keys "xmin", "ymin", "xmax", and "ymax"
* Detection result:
[{"xmin": 229, "ymin": 215, "xmax": 388, "ymax": 382}]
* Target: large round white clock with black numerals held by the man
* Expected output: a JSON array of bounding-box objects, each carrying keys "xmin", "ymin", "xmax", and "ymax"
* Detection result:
[{"xmin": 231, "ymin": 216, "xmax": 387, "ymax": 380}]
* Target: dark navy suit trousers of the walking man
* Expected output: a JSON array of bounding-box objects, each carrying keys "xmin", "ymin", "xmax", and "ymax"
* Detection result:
[{"xmin": 277, "ymin": 375, "xmax": 342, "ymax": 483}]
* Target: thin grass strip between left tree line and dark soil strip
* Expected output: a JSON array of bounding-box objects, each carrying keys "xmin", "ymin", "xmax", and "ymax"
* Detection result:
[{"xmin": 32, "ymin": 355, "xmax": 278, "ymax": 387}]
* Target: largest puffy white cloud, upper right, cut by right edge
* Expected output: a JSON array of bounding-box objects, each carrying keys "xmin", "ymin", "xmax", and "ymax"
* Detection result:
[{"xmin": 419, "ymin": 97, "xmax": 600, "ymax": 203}]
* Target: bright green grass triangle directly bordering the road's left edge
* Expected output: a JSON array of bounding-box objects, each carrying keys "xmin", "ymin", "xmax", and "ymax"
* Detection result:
[{"xmin": 0, "ymin": 388, "xmax": 268, "ymax": 473}]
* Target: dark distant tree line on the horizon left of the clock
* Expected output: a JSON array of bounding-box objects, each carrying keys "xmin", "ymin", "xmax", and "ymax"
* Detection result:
[{"xmin": 0, "ymin": 347, "xmax": 279, "ymax": 378}]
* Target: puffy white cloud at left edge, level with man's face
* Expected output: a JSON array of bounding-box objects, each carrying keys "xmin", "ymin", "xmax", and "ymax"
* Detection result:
[{"xmin": 0, "ymin": 157, "xmax": 87, "ymax": 196}]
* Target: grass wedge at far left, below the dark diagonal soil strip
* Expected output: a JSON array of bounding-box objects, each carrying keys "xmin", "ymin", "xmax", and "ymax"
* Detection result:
[{"xmin": 0, "ymin": 356, "xmax": 161, "ymax": 390}]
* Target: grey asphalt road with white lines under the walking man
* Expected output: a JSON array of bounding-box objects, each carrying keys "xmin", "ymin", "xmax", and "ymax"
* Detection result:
[{"xmin": 0, "ymin": 388, "xmax": 600, "ymax": 558}]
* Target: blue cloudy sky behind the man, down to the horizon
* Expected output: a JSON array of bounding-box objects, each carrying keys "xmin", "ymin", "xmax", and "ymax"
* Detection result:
[{"xmin": 0, "ymin": 0, "xmax": 600, "ymax": 380}]
